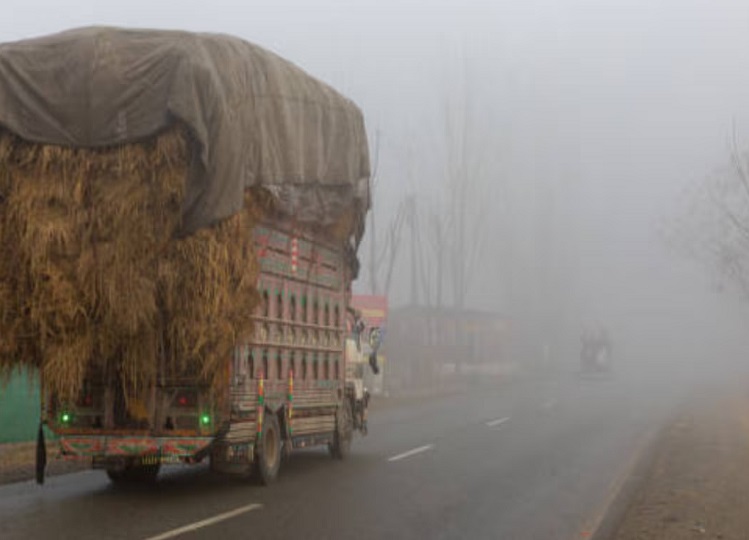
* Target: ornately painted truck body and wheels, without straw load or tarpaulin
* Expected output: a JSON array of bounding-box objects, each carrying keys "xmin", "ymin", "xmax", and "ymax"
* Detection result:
[{"xmin": 53, "ymin": 222, "xmax": 368, "ymax": 484}]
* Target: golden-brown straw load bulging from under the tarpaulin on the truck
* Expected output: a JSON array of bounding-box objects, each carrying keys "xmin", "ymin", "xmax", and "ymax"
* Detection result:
[{"xmin": 0, "ymin": 127, "xmax": 260, "ymax": 399}]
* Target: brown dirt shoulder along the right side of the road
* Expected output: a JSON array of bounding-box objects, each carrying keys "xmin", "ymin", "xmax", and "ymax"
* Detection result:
[{"xmin": 597, "ymin": 390, "xmax": 749, "ymax": 540}]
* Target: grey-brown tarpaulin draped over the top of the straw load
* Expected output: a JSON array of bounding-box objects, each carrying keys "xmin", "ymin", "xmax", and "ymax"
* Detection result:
[{"xmin": 0, "ymin": 27, "xmax": 370, "ymax": 241}]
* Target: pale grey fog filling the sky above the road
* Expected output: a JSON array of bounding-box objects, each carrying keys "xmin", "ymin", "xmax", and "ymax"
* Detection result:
[{"xmin": 5, "ymin": 0, "xmax": 749, "ymax": 386}]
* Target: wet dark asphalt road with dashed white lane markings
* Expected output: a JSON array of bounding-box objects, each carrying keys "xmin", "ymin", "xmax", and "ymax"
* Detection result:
[{"xmin": 0, "ymin": 373, "xmax": 680, "ymax": 540}]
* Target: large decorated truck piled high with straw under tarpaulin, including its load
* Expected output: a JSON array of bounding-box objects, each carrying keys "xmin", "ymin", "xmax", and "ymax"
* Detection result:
[{"xmin": 0, "ymin": 28, "xmax": 369, "ymax": 483}]
